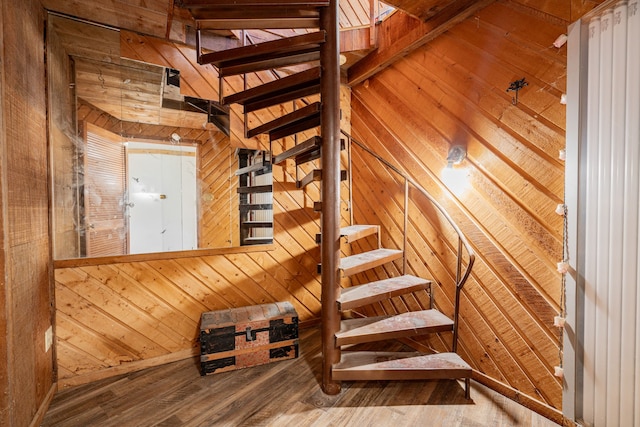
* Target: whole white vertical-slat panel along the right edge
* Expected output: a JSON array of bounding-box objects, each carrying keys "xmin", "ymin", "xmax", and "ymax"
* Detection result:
[{"xmin": 564, "ymin": 0, "xmax": 640, "ymax": 427}]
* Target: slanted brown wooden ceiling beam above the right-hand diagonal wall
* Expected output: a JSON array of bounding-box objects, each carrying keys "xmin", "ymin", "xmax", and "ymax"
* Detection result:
[{"xmin": 347, "ymin": 0, "xmax": 495, "ymax": 86}]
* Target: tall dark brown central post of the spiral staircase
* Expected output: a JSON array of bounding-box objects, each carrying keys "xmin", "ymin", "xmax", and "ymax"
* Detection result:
[{"xmin": 320, "ymin": 0, "xmax": 340, "ymax": 394}]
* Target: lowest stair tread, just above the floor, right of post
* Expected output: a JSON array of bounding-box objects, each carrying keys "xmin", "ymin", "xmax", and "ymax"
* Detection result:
[{"xmin": 331, "ymin": 351, "xmax": 472, "ymax": 381}]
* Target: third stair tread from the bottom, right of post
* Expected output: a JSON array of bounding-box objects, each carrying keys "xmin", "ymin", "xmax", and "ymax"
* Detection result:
[{"xmin": 338, "ymin": 274, "xmax": 431, "ymax": 310}]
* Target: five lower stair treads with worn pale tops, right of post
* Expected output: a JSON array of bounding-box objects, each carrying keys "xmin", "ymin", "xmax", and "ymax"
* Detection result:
[{"xmin": 332, "ymin": 225, "xmax": 472, "ymax": 398}]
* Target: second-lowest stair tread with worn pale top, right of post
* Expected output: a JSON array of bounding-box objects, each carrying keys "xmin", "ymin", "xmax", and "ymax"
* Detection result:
[{"xmin": 336, "ymin": 309, "xmax": 453, "ymax": 346}]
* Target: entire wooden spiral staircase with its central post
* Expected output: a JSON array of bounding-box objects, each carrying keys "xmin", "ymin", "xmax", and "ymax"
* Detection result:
[{"xmin": 181, "ymin": 0, "xmax": 472, "ymax": 397}]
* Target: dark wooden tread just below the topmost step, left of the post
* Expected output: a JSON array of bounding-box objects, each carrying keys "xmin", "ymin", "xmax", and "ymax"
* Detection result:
[{"xmin": 198, "ymin": 31, "xmax": 326, "ymax": 77}]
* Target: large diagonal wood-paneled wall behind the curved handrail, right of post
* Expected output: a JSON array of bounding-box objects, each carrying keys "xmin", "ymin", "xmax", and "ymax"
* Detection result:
[{"xmin": 351, "ymin": 2, "xmax": 566, "ymax": 408}]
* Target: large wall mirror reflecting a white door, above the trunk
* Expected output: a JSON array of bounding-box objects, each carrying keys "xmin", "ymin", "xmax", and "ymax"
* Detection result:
[{"xmin": 47, "ymin": 15, "xmax": 273, "ymax": 259}]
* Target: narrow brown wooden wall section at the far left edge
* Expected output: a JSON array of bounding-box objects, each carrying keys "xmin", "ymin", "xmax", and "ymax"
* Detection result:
[{"xmin": 0, "ymin": 0, "xmax": 54, "ymax": 426}]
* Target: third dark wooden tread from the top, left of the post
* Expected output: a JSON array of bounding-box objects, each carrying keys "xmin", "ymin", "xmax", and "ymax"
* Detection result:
[{"xmin": 221, "ymin": 67, "xmax": 320, "ymax": 113}]
